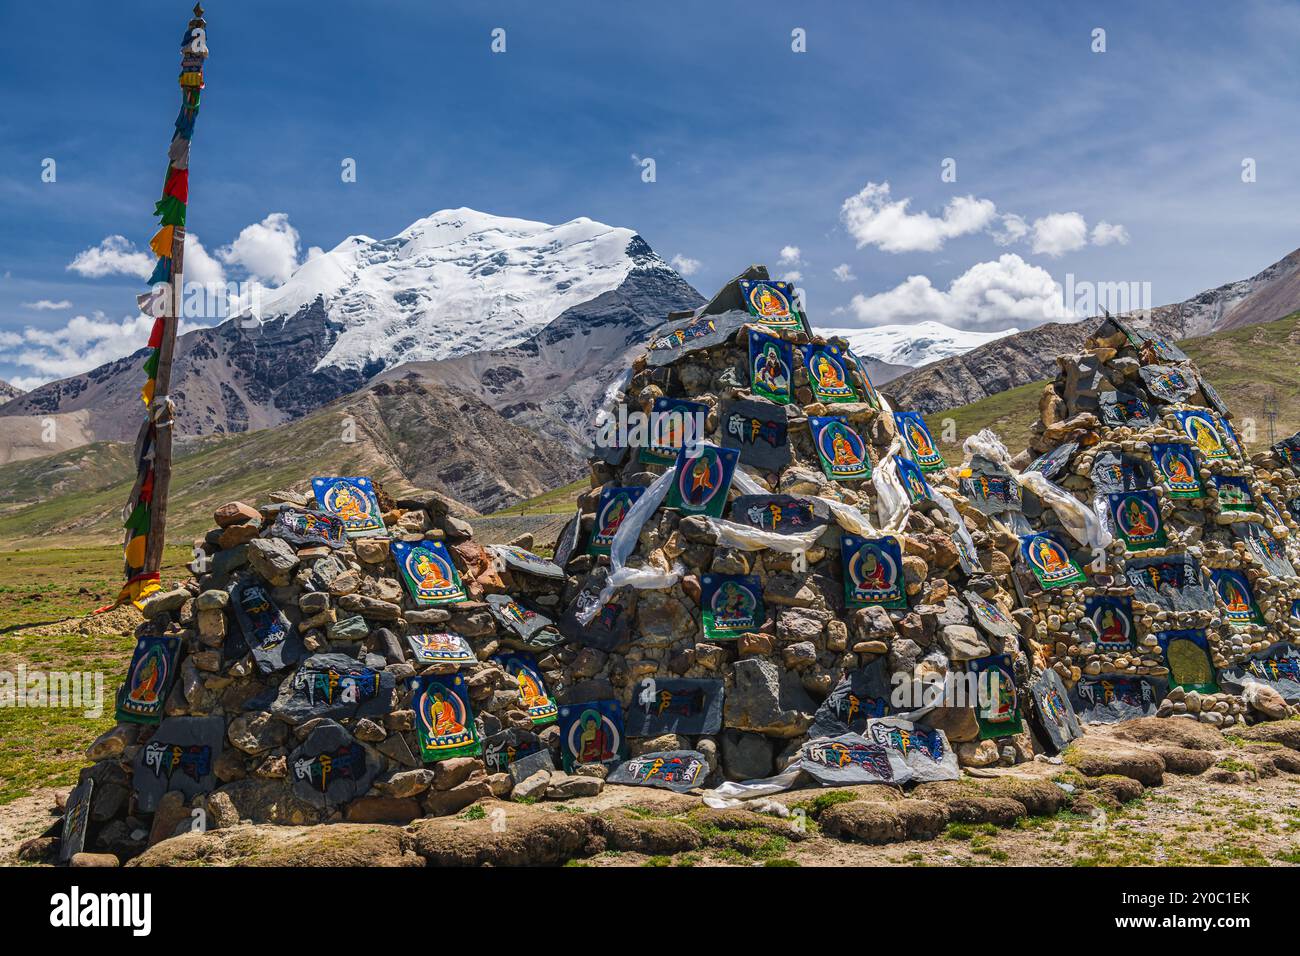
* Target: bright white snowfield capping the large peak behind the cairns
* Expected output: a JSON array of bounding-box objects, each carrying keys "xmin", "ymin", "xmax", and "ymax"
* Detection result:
[{"xmin": 250, "ymin": 208, "xmax": 668, "ymax": 371}]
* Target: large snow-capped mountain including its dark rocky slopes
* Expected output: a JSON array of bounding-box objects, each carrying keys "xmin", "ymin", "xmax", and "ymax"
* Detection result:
[{"xmin": 0, "ymin": 209, "xmax": 701, "ymax": 452}]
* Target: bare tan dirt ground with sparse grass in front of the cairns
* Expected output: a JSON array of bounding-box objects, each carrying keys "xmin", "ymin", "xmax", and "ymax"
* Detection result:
[{"xmin": 10, "ymin": 762, "xmax": 1300, "ymax": 866}]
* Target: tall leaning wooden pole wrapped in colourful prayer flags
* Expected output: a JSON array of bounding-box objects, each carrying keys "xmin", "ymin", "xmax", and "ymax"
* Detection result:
[{"xmin": 111, "ymin": 4, "xmax": 208, "ymax": 607}]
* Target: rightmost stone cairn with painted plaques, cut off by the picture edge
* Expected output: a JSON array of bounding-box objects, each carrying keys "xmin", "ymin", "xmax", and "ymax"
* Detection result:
[{"xmin": 1003, "ymin": 319, "xmax": 1300, "ymax": 728}]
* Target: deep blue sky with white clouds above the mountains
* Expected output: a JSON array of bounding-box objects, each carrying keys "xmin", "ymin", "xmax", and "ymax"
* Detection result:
[{"xmin": 0, "ymin": 0, "xmax": 1300, "ymax": 386}]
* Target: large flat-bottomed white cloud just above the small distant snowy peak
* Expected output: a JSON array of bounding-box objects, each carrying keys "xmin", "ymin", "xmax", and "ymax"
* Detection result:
[{"xmin": 849, "ymin": 252, "xmax": 1073, "ymax": 328}]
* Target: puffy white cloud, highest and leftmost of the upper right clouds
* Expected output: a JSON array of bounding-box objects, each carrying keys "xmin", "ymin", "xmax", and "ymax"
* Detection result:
[{"xmin": 840, "ymin": 182, "xmax": 997, "ymax": 252}]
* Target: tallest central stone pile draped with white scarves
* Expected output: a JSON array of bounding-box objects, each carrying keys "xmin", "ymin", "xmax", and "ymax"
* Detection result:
[{"xmin": 546, "ymin": 267, "xmax": 1043, "ymax": 780}]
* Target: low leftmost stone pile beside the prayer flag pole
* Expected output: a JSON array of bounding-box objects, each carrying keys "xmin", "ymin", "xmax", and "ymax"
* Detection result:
[{"xmin": 62, "ymin": 489, "xmax": 590, "ymax": 858}]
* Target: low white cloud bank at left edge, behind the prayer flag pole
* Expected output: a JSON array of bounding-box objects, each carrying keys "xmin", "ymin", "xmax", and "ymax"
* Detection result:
[{"xmin": 0, "ymin": 312, "xmax": 208, "ymax": 389}]
